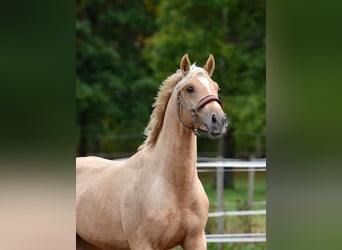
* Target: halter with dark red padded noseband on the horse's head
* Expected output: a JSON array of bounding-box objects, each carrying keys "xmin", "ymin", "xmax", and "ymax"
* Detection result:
[{"xmin": 177, "ymin": 91, "xmax": 222, "ymax": 135}]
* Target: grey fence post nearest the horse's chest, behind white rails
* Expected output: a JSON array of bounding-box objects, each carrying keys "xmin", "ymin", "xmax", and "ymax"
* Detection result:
[{"xmin": 216, "ymin": 157, "xmax": 224, "ymax": 250}]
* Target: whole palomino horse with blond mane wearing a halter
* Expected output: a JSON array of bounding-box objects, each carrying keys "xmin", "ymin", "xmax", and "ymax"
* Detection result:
[{"xmin": 76, "ymin": 54, "xmax": 227, "ymax": 250}]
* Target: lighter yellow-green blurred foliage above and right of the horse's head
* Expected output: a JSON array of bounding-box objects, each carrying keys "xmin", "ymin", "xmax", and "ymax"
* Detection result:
[{"xmin": 143, "ymin": 0, "xmax": 266, "ymax": 155}]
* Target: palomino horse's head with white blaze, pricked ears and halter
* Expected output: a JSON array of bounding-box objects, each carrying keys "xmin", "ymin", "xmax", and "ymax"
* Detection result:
[{"xmin": 176, "ymin": 54, "xmax": 228, "ymax": 138}]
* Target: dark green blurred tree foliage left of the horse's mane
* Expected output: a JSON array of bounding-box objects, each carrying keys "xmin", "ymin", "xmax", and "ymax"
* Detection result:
[{"xmin": 76, "ymin": 0, "xmax": 158, "ymax": 155}]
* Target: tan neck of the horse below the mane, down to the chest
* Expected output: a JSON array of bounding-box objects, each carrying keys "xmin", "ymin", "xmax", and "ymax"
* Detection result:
[{"xmin": 154, "ymin": 93, "xmax": 197, "ymax": 188}]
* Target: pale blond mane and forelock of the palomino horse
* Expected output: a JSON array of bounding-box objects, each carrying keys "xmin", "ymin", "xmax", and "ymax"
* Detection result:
[{"xmin": 138, "ymin": 64, "xmax": 208, "ymax": 151}]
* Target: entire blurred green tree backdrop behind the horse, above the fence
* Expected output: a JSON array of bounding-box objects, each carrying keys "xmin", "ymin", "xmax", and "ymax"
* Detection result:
[{"xmin": 76, "ymin": 0, "xmax": 266, "ymax": 156}]
